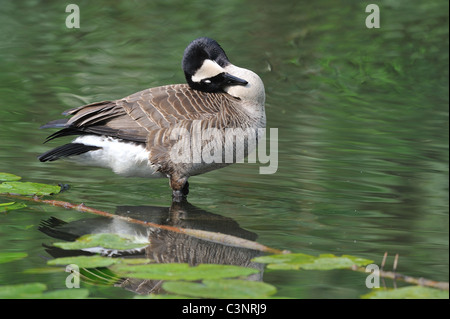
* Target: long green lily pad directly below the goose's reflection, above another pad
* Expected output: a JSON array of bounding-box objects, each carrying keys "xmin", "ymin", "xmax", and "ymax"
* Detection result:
[{"xmin": 113, "ymin": 263, "xmax": 258, "ymax": 280}]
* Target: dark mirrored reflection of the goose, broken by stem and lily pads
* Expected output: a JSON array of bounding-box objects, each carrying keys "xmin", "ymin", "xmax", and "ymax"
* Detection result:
[{"xmin": 39, "ymin": 200, "xmax": 263, "ymax": 294}]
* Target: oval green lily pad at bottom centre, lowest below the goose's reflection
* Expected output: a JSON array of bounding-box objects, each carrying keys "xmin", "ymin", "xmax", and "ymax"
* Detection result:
[{"xmin": 162, "ymin": 279, "xmax": 277, "ymax": 299}]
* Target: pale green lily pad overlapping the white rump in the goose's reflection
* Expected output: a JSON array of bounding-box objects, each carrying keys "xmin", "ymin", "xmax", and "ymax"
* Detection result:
[{"xmin": 53, "ymin": 233, "xmax": 149, "ymax": 250}]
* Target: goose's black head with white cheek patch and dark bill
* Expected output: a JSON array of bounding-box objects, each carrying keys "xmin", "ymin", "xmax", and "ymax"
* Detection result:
[{"xmin": 182, "ymin": 37, "xmax": 247, "ymax": 92}]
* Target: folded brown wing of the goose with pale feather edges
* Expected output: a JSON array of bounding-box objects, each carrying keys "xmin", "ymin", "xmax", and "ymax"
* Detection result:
[{"xmin": 45, "ymin": 84, "xmax": 234, "ymax": 143}]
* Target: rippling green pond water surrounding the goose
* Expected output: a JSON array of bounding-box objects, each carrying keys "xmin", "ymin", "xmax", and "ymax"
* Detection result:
[{"xmin": 0, "ymin": 0, "xmax": 449, "ymax": 298}]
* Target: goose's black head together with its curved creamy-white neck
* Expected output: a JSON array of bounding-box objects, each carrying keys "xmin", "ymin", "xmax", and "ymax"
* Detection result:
[{"xmin": 182, "ymin": 37, "xmax": 264, "ymax": 104}]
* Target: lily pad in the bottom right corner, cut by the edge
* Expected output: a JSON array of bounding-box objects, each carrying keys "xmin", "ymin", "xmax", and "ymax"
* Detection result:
[{"xmin": 361, "ymin": 286, "xmax": 449, "ymax": 299}]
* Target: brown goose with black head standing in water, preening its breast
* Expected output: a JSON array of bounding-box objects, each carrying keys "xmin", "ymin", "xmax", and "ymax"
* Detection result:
[{"xmin": 38, "ymin": 37, "xmax": 266, "ymax": 199}]
